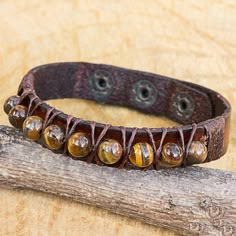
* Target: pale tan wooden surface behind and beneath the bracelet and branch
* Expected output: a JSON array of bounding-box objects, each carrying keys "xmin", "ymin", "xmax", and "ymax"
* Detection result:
[{"xmin": 0, "ymin": 0, "xmax": 236, "ymax": 236}]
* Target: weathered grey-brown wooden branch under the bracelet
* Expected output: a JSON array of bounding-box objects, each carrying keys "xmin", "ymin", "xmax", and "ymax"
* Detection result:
[{"xmin": 0, "ymin": 126, "xmax": 236, "ymax": 235}]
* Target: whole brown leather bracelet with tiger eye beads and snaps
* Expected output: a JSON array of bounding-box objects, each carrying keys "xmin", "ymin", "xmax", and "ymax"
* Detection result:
[{"xmin": 4, "ymin": 62, "xmax": 231, "ymax": 170}]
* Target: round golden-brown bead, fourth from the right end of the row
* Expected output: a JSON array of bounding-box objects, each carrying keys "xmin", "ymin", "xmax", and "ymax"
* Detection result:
[{"xmin": 97, "ymin": 139, "xmax": 123, "ymax": 165}]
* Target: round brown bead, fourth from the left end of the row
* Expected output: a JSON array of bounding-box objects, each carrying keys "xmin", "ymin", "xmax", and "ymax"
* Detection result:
[{"xmin": 43, "ymin": 125, "xmax": 65, "ymax": 150}]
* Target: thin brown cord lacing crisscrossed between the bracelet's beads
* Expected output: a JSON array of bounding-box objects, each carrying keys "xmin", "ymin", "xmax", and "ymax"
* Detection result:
[{"xmin": 20, "ymin": 89, "xmax": 206, "ymax": 170}]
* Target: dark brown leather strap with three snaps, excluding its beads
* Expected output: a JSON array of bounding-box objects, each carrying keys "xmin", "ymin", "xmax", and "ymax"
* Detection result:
[{"xmin": 18, "ymin": 62, "xmax": 231, "ymax": 167}]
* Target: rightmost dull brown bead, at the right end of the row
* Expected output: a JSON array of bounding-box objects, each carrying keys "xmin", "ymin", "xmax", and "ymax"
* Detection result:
[{"xmin": 187, "ymin": 141, "xmax": 207, "ymax": 165}]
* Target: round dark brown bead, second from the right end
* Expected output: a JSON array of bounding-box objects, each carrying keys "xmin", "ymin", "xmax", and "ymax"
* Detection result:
[{"xmin": 159, "ymin": 143, "xmax": 184, "ymax": 167}]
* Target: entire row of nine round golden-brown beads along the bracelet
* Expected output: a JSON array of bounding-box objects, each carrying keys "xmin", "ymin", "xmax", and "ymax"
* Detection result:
[{"xmin": 4, "ymin": 96, "xmax": 207, "ymax": 168}]
